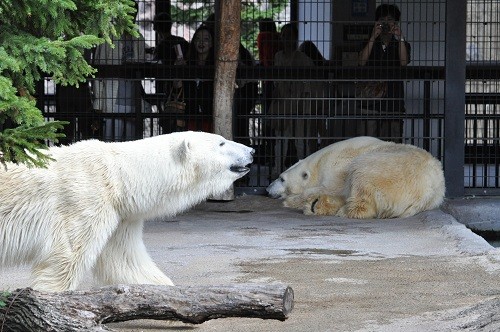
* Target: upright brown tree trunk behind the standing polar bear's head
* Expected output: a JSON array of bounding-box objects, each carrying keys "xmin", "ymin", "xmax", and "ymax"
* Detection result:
[{"xmin": 213, "ymin": 0, "xmax": 241, "ymax": 201}]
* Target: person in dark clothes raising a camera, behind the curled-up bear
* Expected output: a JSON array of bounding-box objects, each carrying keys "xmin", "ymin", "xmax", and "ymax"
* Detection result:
[{"xmin": 359, "ymin": 4, "xmax": 411, "ymax": 141}]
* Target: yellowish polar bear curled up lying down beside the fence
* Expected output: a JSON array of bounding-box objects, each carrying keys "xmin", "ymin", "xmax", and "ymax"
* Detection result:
[{"xmin": 267, "ymin": 137, "xmax": 445, "ymax": 219}]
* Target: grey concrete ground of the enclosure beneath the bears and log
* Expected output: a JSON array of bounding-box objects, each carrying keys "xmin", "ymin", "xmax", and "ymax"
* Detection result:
[{"xmin": 0, "ymin": 196, "xmax": 500, "ymax": 332}]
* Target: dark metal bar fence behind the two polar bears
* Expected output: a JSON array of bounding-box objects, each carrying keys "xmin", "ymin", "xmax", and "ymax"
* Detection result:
[{"xmin": 37, "ymin": 0, "xmax": 500, "ymax": 195}]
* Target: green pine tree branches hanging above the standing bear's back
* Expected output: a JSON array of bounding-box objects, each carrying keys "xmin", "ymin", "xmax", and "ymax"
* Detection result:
[{"xmin": 0, "ymin": 0, "xmax": 137, "ymax": 167}]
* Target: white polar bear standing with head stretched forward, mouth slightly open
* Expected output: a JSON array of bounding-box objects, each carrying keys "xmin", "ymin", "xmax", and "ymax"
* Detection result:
[{"xmin": 0, "ymin": 132, "xmax": 253, "ymax": 291}]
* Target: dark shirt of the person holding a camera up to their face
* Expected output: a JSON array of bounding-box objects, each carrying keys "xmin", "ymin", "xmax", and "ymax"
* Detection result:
[{"xmin": 366, "ymin": 37, "xmax": 411, "ymax": 112}]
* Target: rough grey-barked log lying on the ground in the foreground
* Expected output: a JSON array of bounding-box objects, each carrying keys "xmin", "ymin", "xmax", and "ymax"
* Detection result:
[{"xmin": 0, "ymin": 284, "xmax": 293, "ymax": 332}]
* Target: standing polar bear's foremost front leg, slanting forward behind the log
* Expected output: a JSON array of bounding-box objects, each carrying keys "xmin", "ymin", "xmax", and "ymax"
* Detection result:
[{"xmin": 94, "ymin": 221, "xmax": 173, "ymax": 286}]
